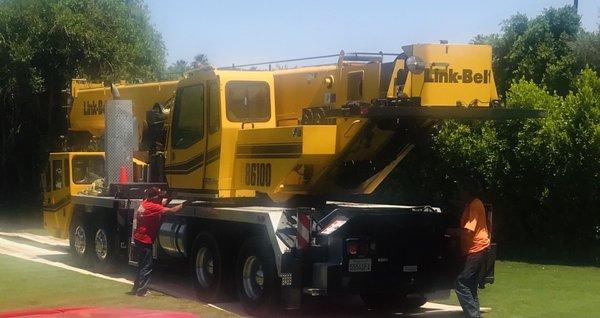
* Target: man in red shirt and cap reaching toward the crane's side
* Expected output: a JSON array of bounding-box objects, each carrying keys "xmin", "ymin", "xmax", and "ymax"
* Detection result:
[{"xmin": 131, "ymin": 187, "xmax": 183, "ymax": 296}]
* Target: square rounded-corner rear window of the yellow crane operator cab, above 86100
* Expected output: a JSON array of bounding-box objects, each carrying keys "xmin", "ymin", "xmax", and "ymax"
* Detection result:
[{"xmin": 225, "ymin": 81, "xmax": 271, "ymax": 123}]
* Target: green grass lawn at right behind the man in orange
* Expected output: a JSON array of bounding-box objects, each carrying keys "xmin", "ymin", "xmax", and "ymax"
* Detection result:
[{"xmin": 444, "ymin": 261, "xmax": 600, "ymax": 318}]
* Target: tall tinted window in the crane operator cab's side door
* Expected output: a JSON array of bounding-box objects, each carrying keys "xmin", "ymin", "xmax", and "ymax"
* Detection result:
[{"xmin": 171, "ymin": 85, "xmax": 204, "ymax": 149}]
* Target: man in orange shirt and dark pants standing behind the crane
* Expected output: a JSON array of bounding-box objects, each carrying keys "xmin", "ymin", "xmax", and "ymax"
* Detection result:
[{"xmin": 456, "ymin": 179, "xmax": 490, "ymax": 317}]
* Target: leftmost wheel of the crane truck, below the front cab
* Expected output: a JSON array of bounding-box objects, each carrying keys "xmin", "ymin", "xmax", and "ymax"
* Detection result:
[{"xmin": 69, "ymin": 215, "xmax": 94, "ymax": 267}]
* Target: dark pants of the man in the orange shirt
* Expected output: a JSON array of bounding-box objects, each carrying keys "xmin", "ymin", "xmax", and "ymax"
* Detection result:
[{"xmin": 456, "ymin": 250, "xmax": 485, "ymax": 317}]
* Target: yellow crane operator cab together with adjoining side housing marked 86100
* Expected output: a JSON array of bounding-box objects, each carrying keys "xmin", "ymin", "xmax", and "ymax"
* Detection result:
[{"xmin": 164, "ymin": 69, "xmax": 337, "ymax": 201}]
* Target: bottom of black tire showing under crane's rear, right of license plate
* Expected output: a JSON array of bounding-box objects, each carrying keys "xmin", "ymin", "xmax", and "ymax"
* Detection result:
[{"xmin": 360, "ymin": 294, "xmax": 427, "ymax": 311}]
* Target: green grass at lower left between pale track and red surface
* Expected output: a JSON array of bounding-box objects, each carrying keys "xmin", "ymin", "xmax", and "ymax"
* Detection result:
[{"xmin": 0, "ymin": 255, "xmax": 231, "ymax": 317}]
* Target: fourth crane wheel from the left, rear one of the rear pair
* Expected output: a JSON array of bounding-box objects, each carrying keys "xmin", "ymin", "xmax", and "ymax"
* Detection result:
[{"xmin": 235, "ymin": 238, "xmax": 281, "ymax": 317}]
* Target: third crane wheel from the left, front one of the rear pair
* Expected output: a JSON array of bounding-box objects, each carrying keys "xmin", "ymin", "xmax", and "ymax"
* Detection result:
[{"xmin": 190, "ymin": 232, "xmax": 232, "ymax": 302}]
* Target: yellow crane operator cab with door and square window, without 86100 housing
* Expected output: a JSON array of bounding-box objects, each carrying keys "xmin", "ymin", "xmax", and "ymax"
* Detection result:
[{"xmin": 164, "ymin": 69, "xmax": 276, "ymax": 197}]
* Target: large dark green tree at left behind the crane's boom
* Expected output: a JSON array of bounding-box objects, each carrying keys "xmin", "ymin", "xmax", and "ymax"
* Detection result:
[{"xmin": 0, "ymin": 0, "xmax": 165, "ymax": 200}]
